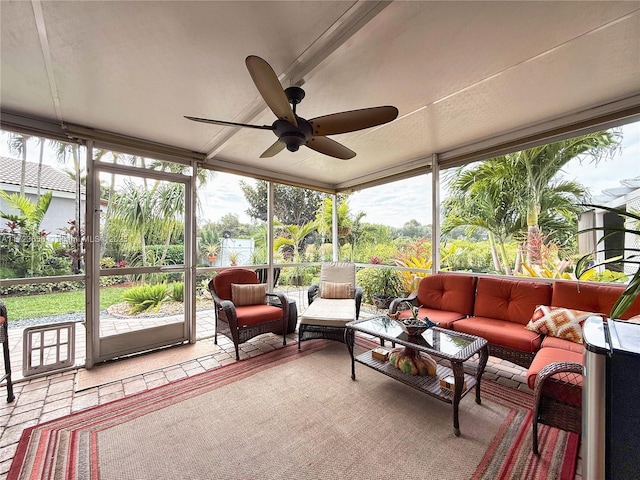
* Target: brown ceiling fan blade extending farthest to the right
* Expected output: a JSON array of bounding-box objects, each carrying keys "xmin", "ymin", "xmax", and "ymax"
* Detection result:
[{"xmin": 309, "ymin": 106, "xmax": 398, "ymax": 135}]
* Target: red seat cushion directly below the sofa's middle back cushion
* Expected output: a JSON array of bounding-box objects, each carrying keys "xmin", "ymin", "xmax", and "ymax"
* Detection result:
[{"xmin": 453, "ymin": 317, "xmax": 542, "ymax": 352}]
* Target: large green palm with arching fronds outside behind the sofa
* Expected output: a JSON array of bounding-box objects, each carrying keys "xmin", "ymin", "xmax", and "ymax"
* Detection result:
[{"xmin": 442, "ymin": 131, "xmax": 620, "ymax": 274}]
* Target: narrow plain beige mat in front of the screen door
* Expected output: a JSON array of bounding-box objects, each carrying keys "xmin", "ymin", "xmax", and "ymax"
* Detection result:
[{"xmin": 75, "ymin": 340, "xmax": 220, "ymax": 392}]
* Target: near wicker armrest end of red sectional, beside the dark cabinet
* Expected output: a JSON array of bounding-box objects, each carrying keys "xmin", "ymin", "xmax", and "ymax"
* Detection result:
[{"xmin": 532, "ymin": 362, "xmax": 583, "ymax": 455}]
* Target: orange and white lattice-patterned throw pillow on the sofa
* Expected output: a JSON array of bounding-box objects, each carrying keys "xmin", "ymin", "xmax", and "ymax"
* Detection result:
[{"xmin": 525, "ymin": 305, "xmax": 602, "ymax": 343}]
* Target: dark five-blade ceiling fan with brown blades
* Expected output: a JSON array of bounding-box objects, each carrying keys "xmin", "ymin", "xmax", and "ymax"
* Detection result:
[{"xmin": 185, "ymin": 55, "xmax": 398, "ymax": 160}]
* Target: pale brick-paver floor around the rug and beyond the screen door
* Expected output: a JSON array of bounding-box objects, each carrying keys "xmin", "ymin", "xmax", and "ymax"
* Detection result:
[{"xmin": 0, "ymin": 302, "xmax": 582, "ymax": 480}]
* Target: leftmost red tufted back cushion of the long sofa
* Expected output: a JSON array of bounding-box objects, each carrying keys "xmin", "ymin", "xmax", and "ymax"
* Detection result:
[{"xmin": 417, "ymin": 273, "xmax": 476, "ymax": 321}]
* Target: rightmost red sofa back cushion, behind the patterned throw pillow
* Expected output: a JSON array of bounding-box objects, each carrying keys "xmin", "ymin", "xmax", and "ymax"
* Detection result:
[{"xmin": 546, "ymin": 281, "xmax": 640, "ymax": 319}]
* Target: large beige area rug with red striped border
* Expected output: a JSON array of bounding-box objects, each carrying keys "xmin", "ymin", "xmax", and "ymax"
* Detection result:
[{"xmin": 8, "ymin": 341, "xmax": 578, "ymax": 480}]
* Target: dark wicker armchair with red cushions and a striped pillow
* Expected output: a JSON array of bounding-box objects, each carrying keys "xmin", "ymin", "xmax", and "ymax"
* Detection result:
[{"xmin": 209, "ymin": 268, "xmax": 289, "ymax": 360}]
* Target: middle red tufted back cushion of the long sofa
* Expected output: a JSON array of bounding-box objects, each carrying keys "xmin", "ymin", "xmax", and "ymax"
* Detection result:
[{"xmin": 474, "ymin": 277, "xmax": 551, "ymax": 324}]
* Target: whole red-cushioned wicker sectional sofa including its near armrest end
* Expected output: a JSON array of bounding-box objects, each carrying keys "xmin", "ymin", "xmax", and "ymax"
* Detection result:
[{"xmin": 389, "ymin": 273, "xmax": 640, "ymax": 453}]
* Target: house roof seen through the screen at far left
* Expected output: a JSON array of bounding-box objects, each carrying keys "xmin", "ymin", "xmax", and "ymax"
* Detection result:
[{"xmin": 0, "ymin": 156, "xmax": 84, "ymax": 193}]
